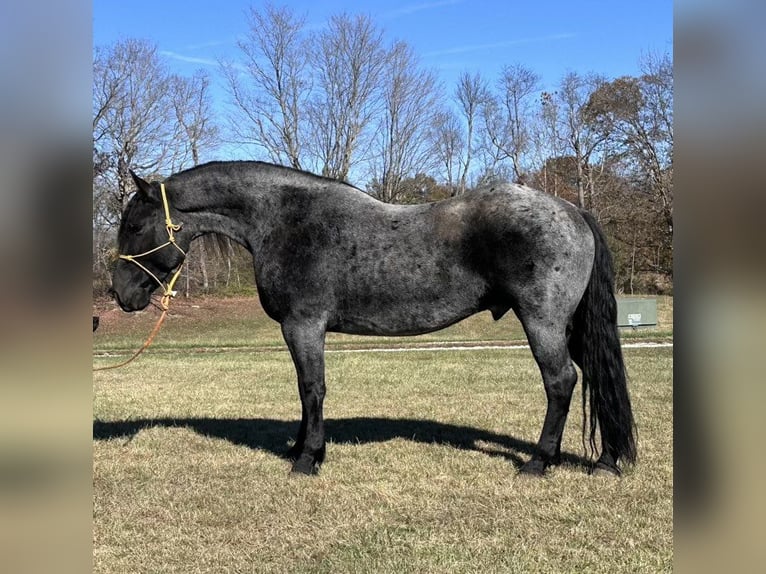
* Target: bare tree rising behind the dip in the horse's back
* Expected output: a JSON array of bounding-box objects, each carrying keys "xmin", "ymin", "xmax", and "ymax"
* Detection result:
[{"xmin": 370, "ymin": 42, "xmax": 439, "ymax": 202}]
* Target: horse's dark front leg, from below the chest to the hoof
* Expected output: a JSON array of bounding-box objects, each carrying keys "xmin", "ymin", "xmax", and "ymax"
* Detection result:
[{"xmin": 282, "ymin": 319, "xmax": 325, "ymax": 474}]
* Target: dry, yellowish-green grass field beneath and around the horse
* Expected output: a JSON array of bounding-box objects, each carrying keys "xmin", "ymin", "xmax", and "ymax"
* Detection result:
[{"xmin": 93, "ymin": 300, "xmax": 673, "ymax": 573}]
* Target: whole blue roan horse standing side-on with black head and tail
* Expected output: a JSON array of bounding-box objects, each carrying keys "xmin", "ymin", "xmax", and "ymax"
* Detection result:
[{"xmin": 112, "ymin": 162, "xmax": 636, "ymax": 474}]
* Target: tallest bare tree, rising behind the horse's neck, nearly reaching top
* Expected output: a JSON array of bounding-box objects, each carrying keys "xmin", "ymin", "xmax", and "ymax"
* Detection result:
[{"xmin": 222, "ymin": 4, "xmax": 311, "ymax": 169}]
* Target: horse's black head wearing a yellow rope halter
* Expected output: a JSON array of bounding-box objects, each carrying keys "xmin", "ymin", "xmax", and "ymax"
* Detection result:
[{"xmin": 112, "ymin": 172, "xmax": 191, "ymax": 311}]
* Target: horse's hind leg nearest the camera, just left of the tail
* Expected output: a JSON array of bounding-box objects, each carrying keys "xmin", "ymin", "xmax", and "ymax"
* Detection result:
[{"xmin": 521, "ymin": 317, "xmax": 577, "ymax": 475}]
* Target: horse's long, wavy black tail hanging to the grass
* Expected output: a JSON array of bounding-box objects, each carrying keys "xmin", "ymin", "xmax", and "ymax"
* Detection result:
[{"xmin": 570, "ymin": 210, "xmax": 636, "ymax": 470}]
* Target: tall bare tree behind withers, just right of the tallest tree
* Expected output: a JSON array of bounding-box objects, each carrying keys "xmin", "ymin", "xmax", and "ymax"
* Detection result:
[{"xmin": 310, "ymin": 14, "xmax": 386, "ymax": 180}]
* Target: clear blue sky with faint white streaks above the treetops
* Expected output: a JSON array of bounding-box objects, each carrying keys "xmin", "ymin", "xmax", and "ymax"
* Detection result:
[{"xmin": 93, "ymin": 0, "xmax": 673, "ymax": 161}]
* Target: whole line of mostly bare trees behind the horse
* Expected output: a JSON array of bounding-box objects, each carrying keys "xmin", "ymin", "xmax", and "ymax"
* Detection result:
[{"xmin": 93, "ymin": 6, "xmax": 673, "ymax": 300}]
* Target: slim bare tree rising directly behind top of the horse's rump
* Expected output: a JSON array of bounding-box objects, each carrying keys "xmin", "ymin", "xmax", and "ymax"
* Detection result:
[{"xmin": 484, "ymin": 64, "xmax": 540, "ymax": 183}]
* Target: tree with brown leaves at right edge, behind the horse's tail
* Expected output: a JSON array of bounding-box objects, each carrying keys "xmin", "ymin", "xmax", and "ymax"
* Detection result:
[{"xmin": 587, "ymin": 50, "xmax": 673, "ymax": 284}]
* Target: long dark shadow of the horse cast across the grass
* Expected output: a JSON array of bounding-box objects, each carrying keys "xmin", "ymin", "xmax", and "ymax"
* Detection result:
[{"xmin": 93, "ymin": 417, "xmax": 592, "ymax": 469}]
